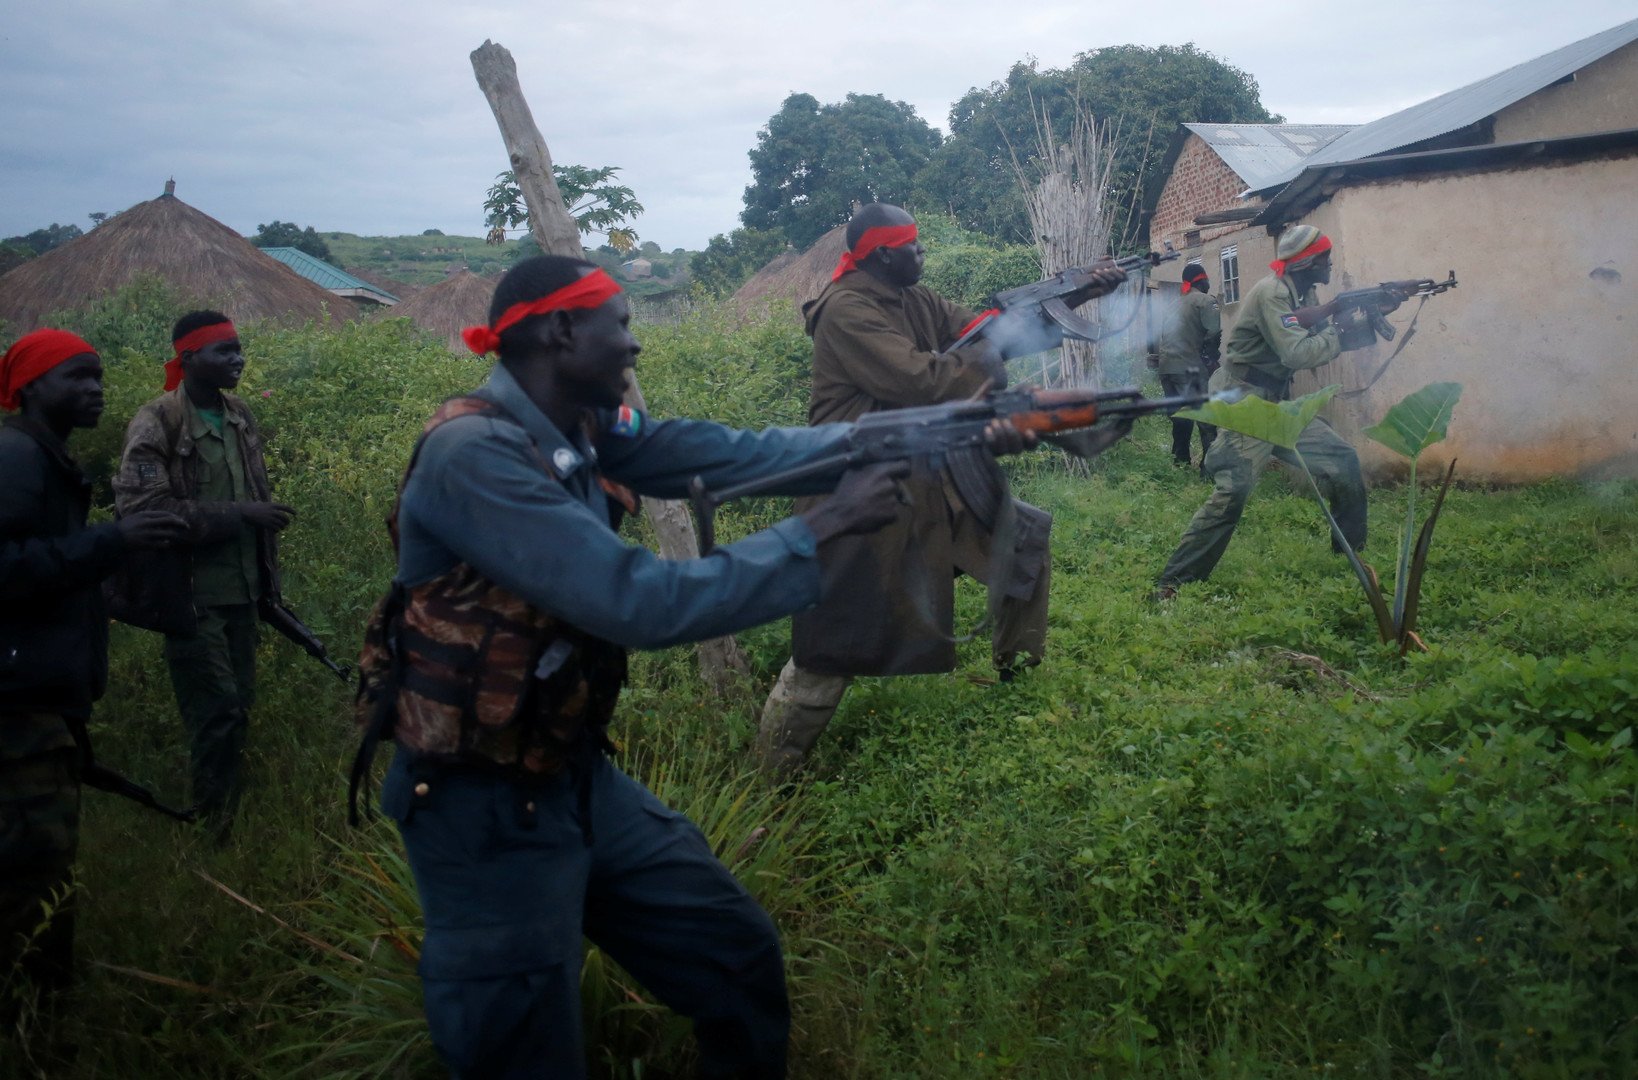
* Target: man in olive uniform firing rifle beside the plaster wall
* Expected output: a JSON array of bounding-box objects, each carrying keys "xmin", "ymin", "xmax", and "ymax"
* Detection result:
[{"xmin": 1155, "ymin": 225, "xmax": 1364, "ymax": 600}]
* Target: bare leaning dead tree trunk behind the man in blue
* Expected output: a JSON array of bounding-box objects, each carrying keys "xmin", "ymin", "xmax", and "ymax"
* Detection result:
[{"xmin": 472, "ymin": 41, "xmax": 750, "ymax": 693}]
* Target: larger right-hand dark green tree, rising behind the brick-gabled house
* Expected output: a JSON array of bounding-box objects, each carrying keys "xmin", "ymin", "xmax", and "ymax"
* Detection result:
[{"xmin": 914, "ymin": 43, "xmax": 1281, "ymax": 243}]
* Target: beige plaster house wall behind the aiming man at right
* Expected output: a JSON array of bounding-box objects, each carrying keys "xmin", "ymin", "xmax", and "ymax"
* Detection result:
[{"xmin": 1294, "ymin": 156, "xmax": 1638, "ymax": 480}]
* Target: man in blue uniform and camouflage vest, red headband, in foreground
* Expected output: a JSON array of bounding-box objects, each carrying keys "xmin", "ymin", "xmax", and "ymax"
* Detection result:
[{"xmin": 355, "ymin": 256, "xmax": 1024, "ymax": 1077}]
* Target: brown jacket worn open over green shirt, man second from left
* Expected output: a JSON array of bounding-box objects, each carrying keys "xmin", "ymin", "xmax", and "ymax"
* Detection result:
[{"xmin": 113, "ymin": 387, "xmax": 278, "ymax": 609}]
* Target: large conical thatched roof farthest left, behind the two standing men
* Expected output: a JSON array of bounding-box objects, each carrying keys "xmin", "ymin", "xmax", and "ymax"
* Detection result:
[{"xmin": 0, "ymin": 184, "xmax": 352, "ymax": 333}]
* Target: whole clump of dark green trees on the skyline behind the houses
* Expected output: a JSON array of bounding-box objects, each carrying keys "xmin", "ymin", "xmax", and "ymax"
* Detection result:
[{"xmin": 740, "ymin": 43, "xmax": 1279, "ymax": 249}]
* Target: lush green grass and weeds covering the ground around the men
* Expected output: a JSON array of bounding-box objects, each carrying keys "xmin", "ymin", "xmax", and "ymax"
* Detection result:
[{"xmin": 0, "ymin": 287, "xmax": 1638, "ymax": 1078}]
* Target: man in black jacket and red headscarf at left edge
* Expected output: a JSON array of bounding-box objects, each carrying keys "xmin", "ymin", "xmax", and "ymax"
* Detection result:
[{"xmin": 0, "ymin": 329, "xmax": 187, "ymax": 1026}]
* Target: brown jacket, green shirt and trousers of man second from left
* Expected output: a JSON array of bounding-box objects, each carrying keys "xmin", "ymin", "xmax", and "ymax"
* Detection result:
[{"xmin": 115, "ymin": 387, "xmax": 277, "ymax": 828}]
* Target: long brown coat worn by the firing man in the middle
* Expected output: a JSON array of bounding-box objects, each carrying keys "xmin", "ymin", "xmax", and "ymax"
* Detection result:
[{"xmin": 791, "ymin": 270, "xmax": 1050, "ymax": 675}]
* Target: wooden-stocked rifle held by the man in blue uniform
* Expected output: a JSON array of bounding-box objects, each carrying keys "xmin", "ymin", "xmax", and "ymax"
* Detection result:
[{"xmin": 688, "ymin": 387, "xmax": 1209, "ymax": 554}]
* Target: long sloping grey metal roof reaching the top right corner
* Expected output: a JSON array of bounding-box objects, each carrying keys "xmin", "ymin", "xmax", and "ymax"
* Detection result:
[{"xmin": 1248, "ymin": 18, "xmax": 1638, "ymax": 190}]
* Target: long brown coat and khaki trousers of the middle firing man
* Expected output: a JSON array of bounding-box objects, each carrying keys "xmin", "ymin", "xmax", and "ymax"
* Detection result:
[{"xmin": 757, "ymin": 272, "xmax": 1052, "ymax": 770}]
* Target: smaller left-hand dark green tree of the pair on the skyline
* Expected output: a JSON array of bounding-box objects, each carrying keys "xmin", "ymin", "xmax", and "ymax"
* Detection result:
[{"xmin": 739, "ymin": 93, "xmax": 942, "ymax": 247}]
